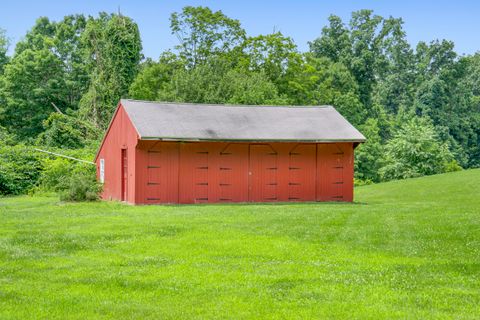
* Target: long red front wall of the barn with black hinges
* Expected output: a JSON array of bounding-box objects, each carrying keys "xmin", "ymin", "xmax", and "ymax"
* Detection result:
[{"xmin": 133, "ymin": 141, "xmax": 354, "ymax": 204}]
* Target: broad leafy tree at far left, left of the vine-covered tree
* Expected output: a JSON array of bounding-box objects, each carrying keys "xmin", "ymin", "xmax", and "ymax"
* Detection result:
[{"xmin": 0, "ymin": 15, "xmax": 89, "ymax": 139}]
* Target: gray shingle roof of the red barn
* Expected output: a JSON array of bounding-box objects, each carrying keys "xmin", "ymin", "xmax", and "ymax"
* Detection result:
[{"xmin": 121, "ymin": 99, "xmax": 365, "ymax": 142}]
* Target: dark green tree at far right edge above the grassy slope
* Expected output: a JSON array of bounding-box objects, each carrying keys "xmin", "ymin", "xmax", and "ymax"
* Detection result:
[{"xmin": 413, "ymin": 40, "xmax": 480, "ymax": 167}]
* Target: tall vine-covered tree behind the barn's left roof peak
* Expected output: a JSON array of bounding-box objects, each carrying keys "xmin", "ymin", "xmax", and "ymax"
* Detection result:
[{"xmin": 80, "ymin": 13, "xmax": 142, "ymax": 128}]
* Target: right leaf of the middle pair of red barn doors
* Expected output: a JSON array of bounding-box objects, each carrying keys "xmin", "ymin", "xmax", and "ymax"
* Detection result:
[{"xmin": 249, "ymin": 144, "xmax": 278, "ymax": 202}]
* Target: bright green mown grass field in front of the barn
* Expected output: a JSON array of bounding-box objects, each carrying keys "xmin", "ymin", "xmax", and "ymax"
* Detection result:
[{"xmin": 0, "ymin": 170, "xmax": 480, "ymax": 319}]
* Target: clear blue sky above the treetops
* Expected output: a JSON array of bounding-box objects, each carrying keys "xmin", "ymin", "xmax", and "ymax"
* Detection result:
[{"xmin": 0, "ymin": 0, "xmax": 480, "ymax": 58}]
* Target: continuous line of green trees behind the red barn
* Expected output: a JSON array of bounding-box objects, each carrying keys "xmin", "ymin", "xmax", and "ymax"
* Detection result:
[{"xmin": 0, "ymin": 6, "xmax": 480, "ymax": 194}]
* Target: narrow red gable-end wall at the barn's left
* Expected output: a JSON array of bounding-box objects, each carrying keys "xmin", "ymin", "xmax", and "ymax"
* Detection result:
[{"xmin": 95, "ymin": 105, "xmax": 138, "ymax": 203}]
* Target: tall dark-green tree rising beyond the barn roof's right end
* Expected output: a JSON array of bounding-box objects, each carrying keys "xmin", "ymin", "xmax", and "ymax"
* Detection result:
[{"xmin": 310, "ymin": 10, "xmax": 413, "ymax": 116}]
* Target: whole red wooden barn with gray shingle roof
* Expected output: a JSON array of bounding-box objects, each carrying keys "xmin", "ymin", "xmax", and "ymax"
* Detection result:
[{"xmin": 95, "ymin": 100, "xmax": 365, "ymax": 204}]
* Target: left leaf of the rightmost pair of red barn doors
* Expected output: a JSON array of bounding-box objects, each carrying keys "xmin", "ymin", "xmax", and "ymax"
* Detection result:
[{"xmin": 288, "ymin": 144, "xmax": 316, "ymax": 201}]
